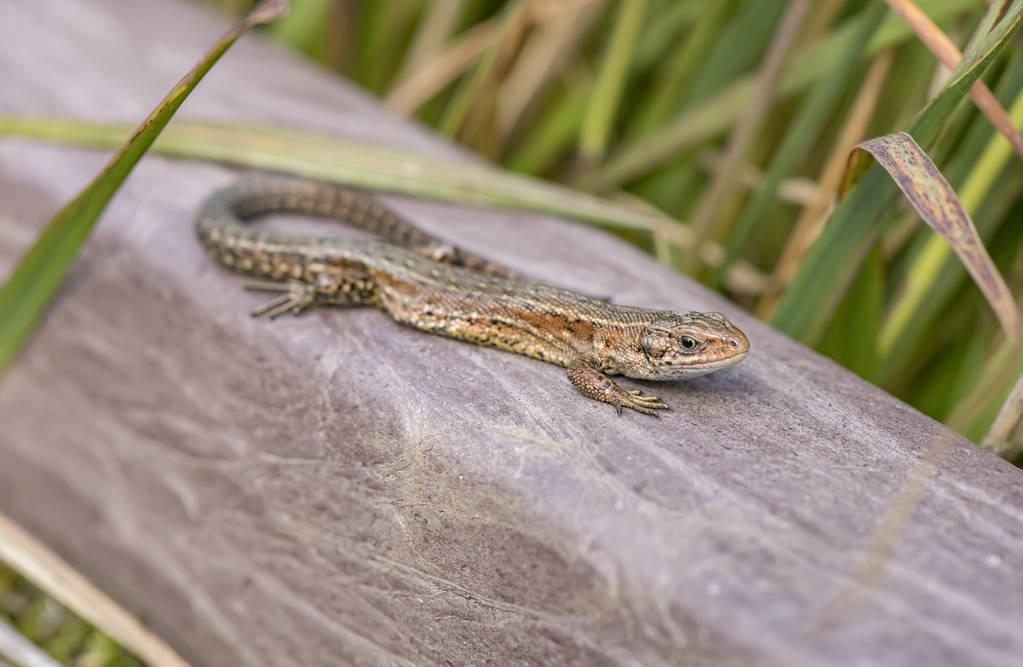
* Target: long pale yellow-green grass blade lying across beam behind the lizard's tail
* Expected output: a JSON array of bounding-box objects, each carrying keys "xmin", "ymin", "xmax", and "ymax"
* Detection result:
[{"xmin": 0, "ymin": 117, "xmax": 659, "ymax": 231}]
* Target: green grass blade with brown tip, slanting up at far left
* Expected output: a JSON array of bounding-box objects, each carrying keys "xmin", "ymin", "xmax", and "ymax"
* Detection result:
[{"xmin": 0, "ymin": 0, "xmax": 287, "ymax": 371}]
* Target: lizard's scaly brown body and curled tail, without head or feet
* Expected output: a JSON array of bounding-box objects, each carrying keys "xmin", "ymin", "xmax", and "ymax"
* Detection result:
[{"xmin": 196, "ymin": 177, "xmax": 660, "ymax": 372}]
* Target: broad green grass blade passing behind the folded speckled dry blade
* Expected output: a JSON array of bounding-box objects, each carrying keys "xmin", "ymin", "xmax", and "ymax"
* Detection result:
[{"xmin": 771, "ymin": 0, "xmax": 1023, "ymax": 343}]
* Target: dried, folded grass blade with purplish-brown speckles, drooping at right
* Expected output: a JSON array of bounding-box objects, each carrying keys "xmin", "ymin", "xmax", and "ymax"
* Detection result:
[{"xmin": 843, "ymin": 132, "xmax": 1020, "ymax": 340}]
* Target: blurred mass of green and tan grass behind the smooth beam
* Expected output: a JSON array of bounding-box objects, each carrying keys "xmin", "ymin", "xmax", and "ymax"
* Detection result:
[{"xmin": 206, "ymin": 0, "xmax": 1023, "ymax": 454}]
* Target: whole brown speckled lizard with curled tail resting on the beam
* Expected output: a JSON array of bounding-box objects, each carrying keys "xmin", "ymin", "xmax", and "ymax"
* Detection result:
[{"xmin": 195, "ymin": 175, "xmax": 750, "ymax": 415}]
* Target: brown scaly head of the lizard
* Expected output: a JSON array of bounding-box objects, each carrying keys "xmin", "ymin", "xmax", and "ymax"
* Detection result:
[{"xmin": 629, "ymin": 312, "xmax": 750, "ymax": 380}]
